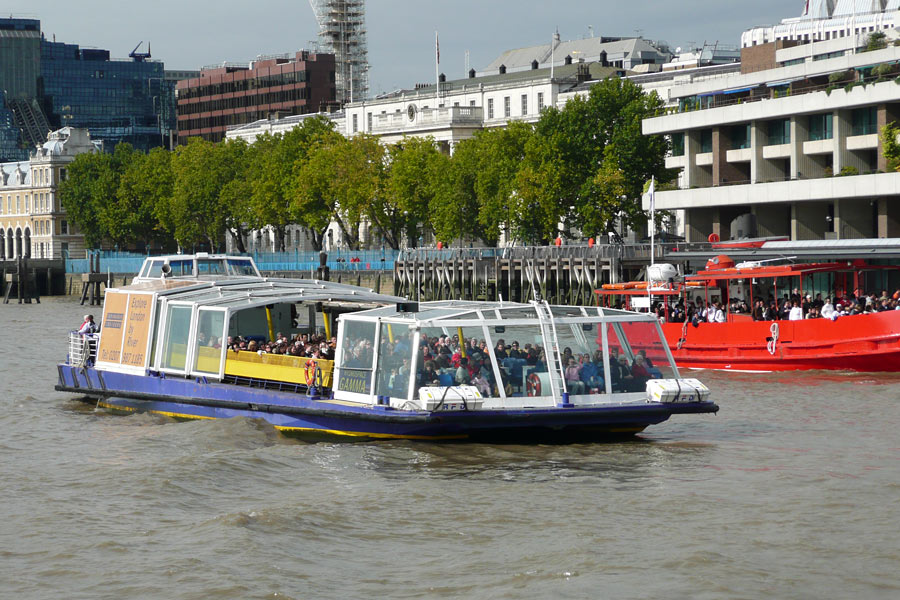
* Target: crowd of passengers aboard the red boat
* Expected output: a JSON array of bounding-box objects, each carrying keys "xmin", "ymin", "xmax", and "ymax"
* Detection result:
[{"xmin": 652, "ymin": 289, "xmax": 900, "ymax": 325}]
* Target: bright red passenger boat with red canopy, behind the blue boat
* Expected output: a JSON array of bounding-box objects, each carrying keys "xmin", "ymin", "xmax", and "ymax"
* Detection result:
[{"xmin": 596, "ymin": 255, "xmax": 900, "ymax": 371}]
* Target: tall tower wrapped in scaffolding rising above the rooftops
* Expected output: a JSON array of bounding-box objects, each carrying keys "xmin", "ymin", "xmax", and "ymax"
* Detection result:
[{"xmin": 309, "ymin": 0, "xmax": 369, "ymax": 104}]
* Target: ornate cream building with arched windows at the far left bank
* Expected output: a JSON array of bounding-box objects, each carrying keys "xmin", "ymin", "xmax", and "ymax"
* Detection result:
[{"xmin": 0, "ymin": 127, "xmax": 99, "ymax": 259}]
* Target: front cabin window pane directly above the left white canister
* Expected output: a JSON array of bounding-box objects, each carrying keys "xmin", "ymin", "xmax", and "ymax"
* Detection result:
[{"xmin": 414, "ymin": 327, "xmax": 509, "ymax": 398}]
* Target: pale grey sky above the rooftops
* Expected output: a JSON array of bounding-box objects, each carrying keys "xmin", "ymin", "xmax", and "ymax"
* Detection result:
[{"xmin": 8, "ymin": 0, "xmax": 805, "ymax": 94}]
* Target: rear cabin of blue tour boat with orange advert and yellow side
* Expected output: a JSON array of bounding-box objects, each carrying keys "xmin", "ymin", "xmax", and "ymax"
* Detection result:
[{"xmin": 87, "ymin": 274, "xmax": 403, "ymax": 390}]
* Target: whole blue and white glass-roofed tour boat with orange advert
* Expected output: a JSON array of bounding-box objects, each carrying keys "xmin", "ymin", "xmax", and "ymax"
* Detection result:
[{"xmin": 56, "ymin": 255, "xmax": 718, "ymax": 441}]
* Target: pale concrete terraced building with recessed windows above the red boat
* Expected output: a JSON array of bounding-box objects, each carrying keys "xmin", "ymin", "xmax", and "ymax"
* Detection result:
[{"xmin": 643, "ymin": 21, "xmax": 900, "ymax": 241}]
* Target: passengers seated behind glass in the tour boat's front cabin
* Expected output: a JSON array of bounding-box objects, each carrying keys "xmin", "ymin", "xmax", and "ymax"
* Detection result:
[{"xmin": 368, "ymin": 335, "xmax": 661, "ymax": 397}]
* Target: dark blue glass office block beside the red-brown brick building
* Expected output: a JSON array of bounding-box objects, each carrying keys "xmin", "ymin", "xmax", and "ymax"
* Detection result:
[{"xmin": 41, "ymin": 40, "xmax": 175, "ymax": 151}]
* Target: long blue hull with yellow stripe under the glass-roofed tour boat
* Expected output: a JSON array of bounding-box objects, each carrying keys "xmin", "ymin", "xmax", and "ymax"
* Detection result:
[{"xmin": 56, "ymin": 365, "xmax": 718, "ymax": 441}]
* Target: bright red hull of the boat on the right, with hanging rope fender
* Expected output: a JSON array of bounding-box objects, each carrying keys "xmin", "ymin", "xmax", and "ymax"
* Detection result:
[{"xmin": 663, "ymin": 311, "xmax": 900, "ymax": 372}]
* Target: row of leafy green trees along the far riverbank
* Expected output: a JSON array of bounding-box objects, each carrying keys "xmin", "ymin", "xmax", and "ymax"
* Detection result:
[{"xmin": 60, "ymin": 78, "xmax": 672, "ymax": 250}]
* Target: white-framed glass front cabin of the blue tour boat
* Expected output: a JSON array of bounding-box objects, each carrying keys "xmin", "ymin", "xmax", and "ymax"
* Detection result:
[{"xmin": 333, "ymin": 301, "xmax": 678, "ymax": 410}]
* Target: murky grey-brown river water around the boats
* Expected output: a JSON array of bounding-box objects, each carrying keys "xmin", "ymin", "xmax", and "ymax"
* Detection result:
[{"xmin": 0, "ymin": 298, "xmax": 900, "ymax": 599}]
